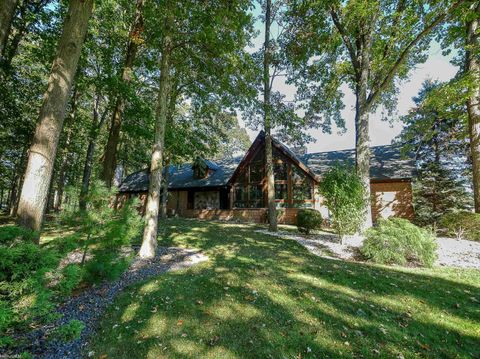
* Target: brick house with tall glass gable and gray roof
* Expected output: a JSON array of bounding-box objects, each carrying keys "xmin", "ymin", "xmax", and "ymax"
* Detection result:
[{"xmin": 119, "ymin": 131, "xmax": 415, "ymax": 224}]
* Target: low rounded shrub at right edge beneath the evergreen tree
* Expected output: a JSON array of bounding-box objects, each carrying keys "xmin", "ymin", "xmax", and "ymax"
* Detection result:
[{"xmin": 438, "ymin": 212, "xmax": 480, "ymax": 241}]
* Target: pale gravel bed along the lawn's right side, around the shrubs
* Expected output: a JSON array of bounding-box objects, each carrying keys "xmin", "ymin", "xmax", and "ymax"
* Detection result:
[{"xmin": 257, "ymin": 230, "xmax": 480, "ymax": 269}]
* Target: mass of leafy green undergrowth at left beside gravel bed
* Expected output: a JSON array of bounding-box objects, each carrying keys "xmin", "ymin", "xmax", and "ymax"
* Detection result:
[{"xmin": 0, "ymin": 186, "xmax": 142, "ymax": 348}]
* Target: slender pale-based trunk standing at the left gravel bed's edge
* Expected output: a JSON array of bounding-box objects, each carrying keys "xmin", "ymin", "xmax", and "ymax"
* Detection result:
[{"xmin": 139, "ymin": 23, "xmax": 173, "ymax": 258}]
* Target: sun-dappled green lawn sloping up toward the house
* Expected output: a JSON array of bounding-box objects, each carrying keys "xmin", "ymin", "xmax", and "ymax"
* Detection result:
[{"xmin": 88, "ymin": 220, "xmax": 480, "ymax": 358}]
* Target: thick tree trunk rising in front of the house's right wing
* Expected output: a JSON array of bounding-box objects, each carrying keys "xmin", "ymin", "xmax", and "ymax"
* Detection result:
[{"xmin": 355, "ymin": 40, "xmax": 372, "ymax": 230}]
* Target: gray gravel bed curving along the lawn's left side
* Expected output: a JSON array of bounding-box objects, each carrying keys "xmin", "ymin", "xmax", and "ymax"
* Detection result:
[{"xmin": 12, "ymin": 247, "xmax": 208, "ymax": 359}]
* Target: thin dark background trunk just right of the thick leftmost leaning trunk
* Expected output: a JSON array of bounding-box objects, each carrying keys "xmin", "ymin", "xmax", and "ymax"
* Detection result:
[{"xmin": 78, "ymin": 95, "xmax": 108, "ymax": 210}]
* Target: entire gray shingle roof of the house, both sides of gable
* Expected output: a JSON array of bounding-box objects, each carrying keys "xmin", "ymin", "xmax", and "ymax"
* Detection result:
[{"xmin": 119, "ymin": 144, "xmax": 415, "ymax": 192}]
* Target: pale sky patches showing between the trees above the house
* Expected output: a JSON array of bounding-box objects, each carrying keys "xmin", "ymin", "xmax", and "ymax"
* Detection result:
[{"xmin": 242, "ymin": 9, "xmax": 458, "ymax": 153}]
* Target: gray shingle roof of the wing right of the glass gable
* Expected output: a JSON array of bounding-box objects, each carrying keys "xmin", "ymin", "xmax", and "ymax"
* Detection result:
[{"xmin": 300, "ymin": 145, "xmax": 415, "ymax": 179}]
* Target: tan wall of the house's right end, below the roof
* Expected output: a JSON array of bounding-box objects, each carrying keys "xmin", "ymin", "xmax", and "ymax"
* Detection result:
[{"xmin": 371, "ymin": 181, "xmax": 414, "ymax": 222}]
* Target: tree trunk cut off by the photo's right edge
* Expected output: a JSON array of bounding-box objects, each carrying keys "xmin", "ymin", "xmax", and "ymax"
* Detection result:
[{"xmin": 465, "ymin": 1, "xmax": 480, "ymax": 213}]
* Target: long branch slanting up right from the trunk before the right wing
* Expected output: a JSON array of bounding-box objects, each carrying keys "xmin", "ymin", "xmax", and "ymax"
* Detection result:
[{"xmin": 367, "ymin": 0, "xmax": 465, "ymax": 105}]
